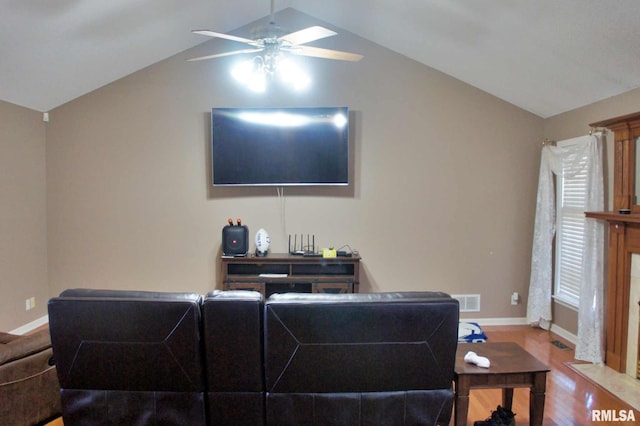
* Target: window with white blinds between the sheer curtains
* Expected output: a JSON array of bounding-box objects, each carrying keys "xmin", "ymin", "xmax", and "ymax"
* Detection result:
[{"xmin": 554, "ymin": 140, "xmax": 588, "ymax": 308}]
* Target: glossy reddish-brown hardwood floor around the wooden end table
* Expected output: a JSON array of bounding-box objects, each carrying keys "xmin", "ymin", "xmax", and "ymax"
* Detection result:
[{"xmin": 47, "ymin": 325, "xmax": 640, "ymax": 426}]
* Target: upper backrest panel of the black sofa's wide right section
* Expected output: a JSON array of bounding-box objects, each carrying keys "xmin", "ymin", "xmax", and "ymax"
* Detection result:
[{"xmin": 264, "ymin": 292, "xmax": 459, "ymax": 393}]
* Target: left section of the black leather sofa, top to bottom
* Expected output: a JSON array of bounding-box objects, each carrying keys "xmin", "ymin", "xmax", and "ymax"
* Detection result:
[{"xmin": 48, "ymin": 289, "xmax": 206, "ymax": 426}]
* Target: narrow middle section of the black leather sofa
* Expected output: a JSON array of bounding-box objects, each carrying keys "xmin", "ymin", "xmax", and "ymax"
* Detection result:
[{"xmin": 202, "ymin": 290, "xmax": 264, "ymax": 426}]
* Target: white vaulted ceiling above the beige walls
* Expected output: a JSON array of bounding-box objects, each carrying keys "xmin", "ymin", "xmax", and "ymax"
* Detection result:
[{"xmin": 0, "ymin": 0, "xmax": 640, "ymax": 117}]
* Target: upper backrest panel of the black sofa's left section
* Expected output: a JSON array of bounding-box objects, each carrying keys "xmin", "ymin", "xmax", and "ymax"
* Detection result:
[{"xmin": 48, "ymin": 289, "xmax": 204, "ymax": 392}]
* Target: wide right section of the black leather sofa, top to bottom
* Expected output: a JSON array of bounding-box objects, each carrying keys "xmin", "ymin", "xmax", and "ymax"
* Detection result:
[{"xmin": 264, "ymin": 293, "xmax": 459, "ymax": 426}]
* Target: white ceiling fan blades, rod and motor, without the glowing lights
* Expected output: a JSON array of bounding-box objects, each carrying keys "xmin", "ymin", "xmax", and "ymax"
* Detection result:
[{"xmin": 188, "ymin": 0, "xmax": 363, "ymax": 67}]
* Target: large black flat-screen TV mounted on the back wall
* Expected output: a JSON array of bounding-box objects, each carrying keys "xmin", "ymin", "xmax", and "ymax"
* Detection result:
[{"xmin": 211, "ymin": 107, "xmax": 349, "ymax": 186}]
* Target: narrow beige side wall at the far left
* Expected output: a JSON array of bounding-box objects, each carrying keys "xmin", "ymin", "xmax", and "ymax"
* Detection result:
[{"xmin": 0, "ymin": 101, "xmax": 49, "ymax": 331}]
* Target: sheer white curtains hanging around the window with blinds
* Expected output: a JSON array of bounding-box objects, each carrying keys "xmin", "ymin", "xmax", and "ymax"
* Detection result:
[{"xmin": 527, "ymin": 134, "xmax": 604, "ymax": 363}]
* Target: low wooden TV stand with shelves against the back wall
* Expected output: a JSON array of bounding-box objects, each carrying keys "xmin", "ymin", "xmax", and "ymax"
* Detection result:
[{"xmin": 222, "ymin": 253, "xmax": 360, "ymax": 298}]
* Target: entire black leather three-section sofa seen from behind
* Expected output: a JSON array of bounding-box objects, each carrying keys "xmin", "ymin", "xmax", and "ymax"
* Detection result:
[{"xmin": 49, "ymin": 289, "xmax": 459, "ymax": 426}]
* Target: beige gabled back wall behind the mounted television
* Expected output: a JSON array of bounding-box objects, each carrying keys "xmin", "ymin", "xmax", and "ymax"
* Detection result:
[{"xmin": 47, "ymin": 10, "xmax": 543, "ymax": 318}]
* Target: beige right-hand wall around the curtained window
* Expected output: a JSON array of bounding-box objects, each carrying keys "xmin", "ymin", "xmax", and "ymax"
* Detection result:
[{"xmin": 544, "ymin": 89, "xmax": 640, "ymax": 333}]
